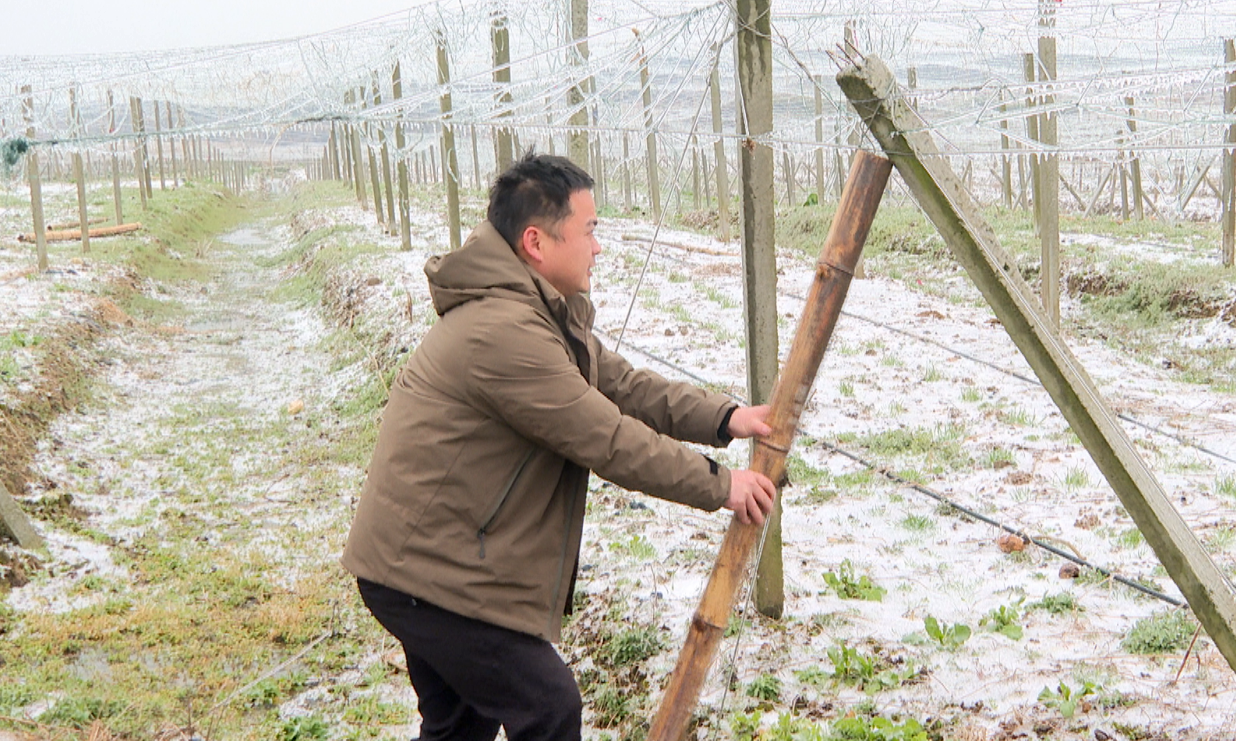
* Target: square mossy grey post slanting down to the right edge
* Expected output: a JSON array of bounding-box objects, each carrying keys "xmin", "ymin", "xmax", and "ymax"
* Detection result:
[{"xmin": 837, "ymin": 57, "xmax": 1236, "ymax": 669}]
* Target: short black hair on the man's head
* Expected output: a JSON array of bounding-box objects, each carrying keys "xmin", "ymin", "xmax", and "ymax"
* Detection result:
[{"xmin": 486, "ymin": 149, "xmax": 595, "ymax": 248}]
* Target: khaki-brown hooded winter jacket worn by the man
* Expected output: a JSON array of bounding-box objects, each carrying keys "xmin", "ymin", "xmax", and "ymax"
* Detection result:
[{"xmin": 342, "ymin": 222, "xmax": 734, "ymax": 641}]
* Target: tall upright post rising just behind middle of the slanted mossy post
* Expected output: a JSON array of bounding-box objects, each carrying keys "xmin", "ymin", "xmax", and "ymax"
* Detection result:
[{"xmin": 1038, "ymin": 0, "xmax": 1060, "ymax": 326}]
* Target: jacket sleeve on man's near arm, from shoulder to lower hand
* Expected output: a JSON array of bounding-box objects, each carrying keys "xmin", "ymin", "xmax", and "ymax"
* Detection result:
[{"xmin": 467, "ymin": 309, "xmax": 729, "ymax": 510}]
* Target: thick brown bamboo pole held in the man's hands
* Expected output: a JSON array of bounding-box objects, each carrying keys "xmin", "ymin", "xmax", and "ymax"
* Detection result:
[{"xmin": 648, "ymin": 152, "xmax": 892, "ymax": 741}]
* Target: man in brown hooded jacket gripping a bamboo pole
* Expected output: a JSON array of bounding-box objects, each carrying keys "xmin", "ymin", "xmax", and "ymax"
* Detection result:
[{"xmin": 342, "ymin": 152, "xmax": 775, "ymax": 741}]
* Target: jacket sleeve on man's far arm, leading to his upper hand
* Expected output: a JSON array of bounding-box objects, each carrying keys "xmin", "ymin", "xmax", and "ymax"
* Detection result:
[{"xmin": 590, "ymin": 336, "xmax": 738, "ymax": 447}]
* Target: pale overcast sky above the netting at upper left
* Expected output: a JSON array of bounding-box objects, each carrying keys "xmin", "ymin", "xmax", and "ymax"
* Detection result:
[{"xmin": 0, "ymin": 0, "xmax": 440, "ymax": 54}]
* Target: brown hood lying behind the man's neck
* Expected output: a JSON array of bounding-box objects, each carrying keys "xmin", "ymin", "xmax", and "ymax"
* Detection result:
[{"xmin": 425, "ymin": 221, "xmax": 551, "ymax": 316}]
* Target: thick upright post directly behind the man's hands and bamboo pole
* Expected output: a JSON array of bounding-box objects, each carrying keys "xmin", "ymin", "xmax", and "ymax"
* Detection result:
[{"xmin": 734, "ymin": 0, "xmax": 785, "ymax": 618}]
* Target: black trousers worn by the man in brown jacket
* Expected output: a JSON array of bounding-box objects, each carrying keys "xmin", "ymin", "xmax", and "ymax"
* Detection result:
[{"xmin": 357, "ymin": 579, "xmax": 582, "ymax": 741}]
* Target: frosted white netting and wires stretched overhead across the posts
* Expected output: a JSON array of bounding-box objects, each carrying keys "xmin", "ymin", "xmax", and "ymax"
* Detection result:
[{"xmin": 0, "ymin": 0, "xmax": 1236, "ymax": 207}]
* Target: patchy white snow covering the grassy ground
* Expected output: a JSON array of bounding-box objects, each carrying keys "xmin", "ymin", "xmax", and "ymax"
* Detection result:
[{"xmin": 0, "ymin": 175, "xmax": 1236, "ymax": 740}]
